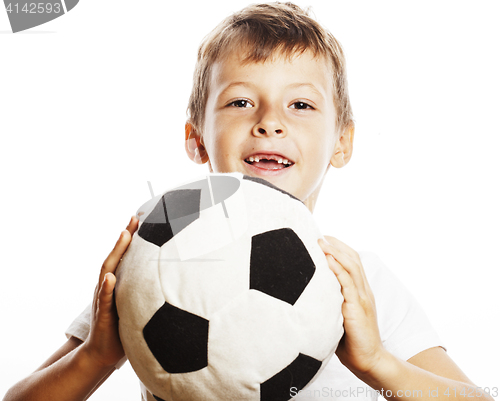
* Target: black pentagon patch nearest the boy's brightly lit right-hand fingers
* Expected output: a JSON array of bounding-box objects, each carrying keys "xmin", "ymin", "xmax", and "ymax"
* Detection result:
[{"xmin": 250, "ymin": 228, "xmax": 316, "ymax": 305}]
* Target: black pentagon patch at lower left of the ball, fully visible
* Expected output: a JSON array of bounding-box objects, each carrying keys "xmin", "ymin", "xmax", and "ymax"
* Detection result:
[{"xmin": 142, "ymin": 302, "xmax": 208, "ymax": 373}]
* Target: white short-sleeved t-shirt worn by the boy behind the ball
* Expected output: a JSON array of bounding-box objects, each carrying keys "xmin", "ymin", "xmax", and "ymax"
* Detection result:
[{"xmin": 66, "ymin": 252, "xmax": 444, "ymax": 401}]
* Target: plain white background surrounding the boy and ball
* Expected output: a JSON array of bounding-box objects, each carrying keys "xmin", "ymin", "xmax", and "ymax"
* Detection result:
[{"xmin": 0, "ymin": 0, "xmax": 500, "ymax": 400}]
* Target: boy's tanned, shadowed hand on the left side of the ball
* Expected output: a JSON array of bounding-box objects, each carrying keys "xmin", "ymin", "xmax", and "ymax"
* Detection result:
[{"xmin": 82, "ymin": 217, "xmax": 139, "ymax": 367}]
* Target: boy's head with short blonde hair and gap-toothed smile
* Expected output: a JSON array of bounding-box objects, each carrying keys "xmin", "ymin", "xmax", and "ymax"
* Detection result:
[{"xmin": 186, "ymin": 3, "xmax": 354, "ymax": 211}]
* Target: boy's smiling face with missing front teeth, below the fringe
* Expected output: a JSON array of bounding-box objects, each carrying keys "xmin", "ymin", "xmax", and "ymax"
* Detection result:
[{"xmin": 188, "ymin": 51, "xmax": 352, "ymax": 210}]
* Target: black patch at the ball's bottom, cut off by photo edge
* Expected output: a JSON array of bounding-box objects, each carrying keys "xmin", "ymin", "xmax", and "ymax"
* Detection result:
[{"xmin": 260, "ymin": 354, "xmax": 321, "ymax": 401}]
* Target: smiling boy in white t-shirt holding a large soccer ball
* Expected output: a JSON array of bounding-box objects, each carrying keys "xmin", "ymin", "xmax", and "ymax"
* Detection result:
[{"xmin": 5, "ymin": 4, "xmax": 491, "ymax": 400}]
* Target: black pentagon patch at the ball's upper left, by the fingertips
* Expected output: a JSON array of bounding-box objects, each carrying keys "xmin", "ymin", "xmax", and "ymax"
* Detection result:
[{"xmin": 138, "ymin": 189, "xmax": 201, "ymax": 246}]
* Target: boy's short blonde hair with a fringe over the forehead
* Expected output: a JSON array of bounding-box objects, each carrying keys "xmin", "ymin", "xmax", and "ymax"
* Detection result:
[{"xmin": 187, "ymin": 2, "xmax": 354, "ymax": 133}]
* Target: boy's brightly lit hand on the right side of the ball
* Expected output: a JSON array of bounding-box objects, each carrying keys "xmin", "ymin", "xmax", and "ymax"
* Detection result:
[{"xmin": 318, "ymin": 237, "xmax": 385, "ymax": 378}]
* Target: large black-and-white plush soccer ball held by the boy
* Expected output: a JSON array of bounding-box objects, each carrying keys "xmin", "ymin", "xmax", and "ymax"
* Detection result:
[{"xmin": 115, "ymin": 173, "xmax": 343, "ymax": 401}]
